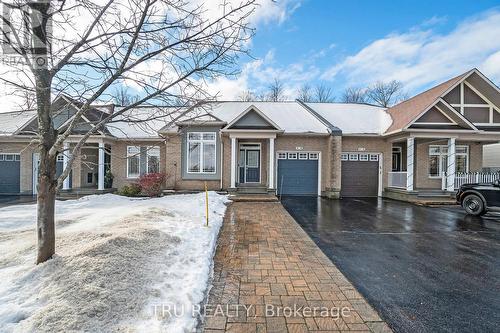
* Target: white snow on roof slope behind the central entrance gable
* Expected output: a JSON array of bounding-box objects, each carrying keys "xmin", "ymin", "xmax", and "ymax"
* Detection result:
[{"xmin": 209, "ymin": 102, "xmax": 329, "ymax": 134}]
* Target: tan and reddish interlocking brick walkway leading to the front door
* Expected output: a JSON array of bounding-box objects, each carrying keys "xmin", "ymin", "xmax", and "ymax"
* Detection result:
[{"xmin": 204, "ymin": 202, "xmax": 390, "ymax": 333}]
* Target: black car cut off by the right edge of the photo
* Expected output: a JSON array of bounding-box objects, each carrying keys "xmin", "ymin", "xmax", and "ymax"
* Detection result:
[{"xmin": 457, "ymin": 180, "xmax": 500, "ymax": 216}]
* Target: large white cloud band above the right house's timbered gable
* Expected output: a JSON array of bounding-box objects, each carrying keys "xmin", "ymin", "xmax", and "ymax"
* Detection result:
[{"xmin": 322, "ymin": 10, "xmax": 500, "ymax": 90}]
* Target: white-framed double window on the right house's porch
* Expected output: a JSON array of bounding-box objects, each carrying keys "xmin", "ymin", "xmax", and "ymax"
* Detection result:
[{"xmin": 429, "ymin": 146, "xmax": 469, "ymax": 178}]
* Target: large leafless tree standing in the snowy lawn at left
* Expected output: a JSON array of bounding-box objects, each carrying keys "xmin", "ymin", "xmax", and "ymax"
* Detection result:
[{"xmin": 0, "ymin": 0, "xmax": 256, "ymax": 263}]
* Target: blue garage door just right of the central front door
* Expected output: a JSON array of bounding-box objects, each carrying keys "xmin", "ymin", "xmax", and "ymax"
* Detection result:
[{"xmin": 277, "ymin": 152, "xmax": 319, "ymax": 196}]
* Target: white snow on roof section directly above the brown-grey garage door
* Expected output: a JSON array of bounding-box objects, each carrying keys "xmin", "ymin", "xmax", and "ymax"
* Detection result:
[{"xmin": 306, "ymin": 103, "xmax": 392, "ymax": 134}]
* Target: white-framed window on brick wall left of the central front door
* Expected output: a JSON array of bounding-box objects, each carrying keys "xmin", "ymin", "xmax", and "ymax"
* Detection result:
[{"xmin": 187, "ymin": 132, "xmax": 216, "ymax": 173}]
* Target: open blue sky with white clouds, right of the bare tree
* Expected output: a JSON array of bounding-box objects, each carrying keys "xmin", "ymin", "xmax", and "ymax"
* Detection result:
[{"xmin": 206, "ymin": 0, "xmax": 500, "ymax": 100}]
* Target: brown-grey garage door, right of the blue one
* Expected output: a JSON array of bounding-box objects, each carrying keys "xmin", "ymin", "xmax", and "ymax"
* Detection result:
[{"xmin": 340, "ymin": 153, "xmax": 379, "ymax": 197}]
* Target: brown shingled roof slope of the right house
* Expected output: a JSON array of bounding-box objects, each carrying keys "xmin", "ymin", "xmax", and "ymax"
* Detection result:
[{"xmin": 385, "ymin": 70, "xmax": 474, "ymax": 133}]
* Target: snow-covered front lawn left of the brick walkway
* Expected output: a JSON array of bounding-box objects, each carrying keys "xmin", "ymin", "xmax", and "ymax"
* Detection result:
[{"xmin": 0, "ymin": 192, "xmax": 228, "ymax": 333}]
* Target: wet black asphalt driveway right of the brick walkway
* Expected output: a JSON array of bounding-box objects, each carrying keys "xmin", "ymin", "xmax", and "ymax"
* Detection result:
[{"xmin": 282, "ymin": 197, "xmax": 500, "ymax": 332}]
